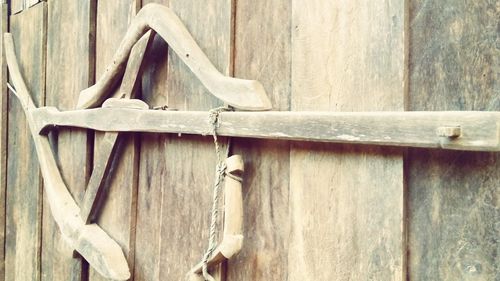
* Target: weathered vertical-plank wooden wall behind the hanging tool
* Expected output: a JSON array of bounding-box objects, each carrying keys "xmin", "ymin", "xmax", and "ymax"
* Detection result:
[{"xmin": 0, "ymin": 0, "xmax": 500, "ymax": 281}]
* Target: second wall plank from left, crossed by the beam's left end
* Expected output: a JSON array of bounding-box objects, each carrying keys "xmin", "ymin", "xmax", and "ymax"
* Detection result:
[{"xmin": 41, "ymin": 1, "xmax": 94, "ymax": 280}]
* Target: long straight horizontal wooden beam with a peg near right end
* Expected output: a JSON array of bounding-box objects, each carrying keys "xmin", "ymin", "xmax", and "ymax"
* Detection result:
[{"xmin": 33, "ymin": 107, "xmax": 500, "ymax": 151}]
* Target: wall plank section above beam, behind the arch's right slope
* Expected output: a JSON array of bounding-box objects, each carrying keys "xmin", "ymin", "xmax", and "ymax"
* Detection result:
[{"xmin": 167, "ymin": 0, "xmax": 231, "ymax": 110}]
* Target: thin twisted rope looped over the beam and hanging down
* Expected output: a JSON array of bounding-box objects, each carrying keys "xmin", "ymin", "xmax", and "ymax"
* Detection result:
[{"xmin": 202, "ymin": 107, "xmax": 231, "ymax": 281}]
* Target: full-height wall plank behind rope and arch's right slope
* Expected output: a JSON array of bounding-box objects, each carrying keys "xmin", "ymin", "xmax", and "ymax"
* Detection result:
[{"xmin": 158, "ymin": 0, "xmax": 232, "ymax": 280}]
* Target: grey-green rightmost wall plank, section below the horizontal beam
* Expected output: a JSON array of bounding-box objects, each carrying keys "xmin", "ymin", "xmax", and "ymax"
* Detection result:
[{"xmin": 408, "ymin": 149, "xmax": 500, "ymax": 280}]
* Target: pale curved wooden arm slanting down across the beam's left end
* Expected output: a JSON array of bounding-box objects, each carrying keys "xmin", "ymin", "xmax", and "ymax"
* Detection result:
[{"xmin": 4, "ymin": 33, "xmax": 130, "ymax": 280}]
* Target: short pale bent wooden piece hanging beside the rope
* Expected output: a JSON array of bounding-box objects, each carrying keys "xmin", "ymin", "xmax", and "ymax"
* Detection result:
[{"xmin": 187, "ymin": 155, "xmax": 244, "ymax": 281}]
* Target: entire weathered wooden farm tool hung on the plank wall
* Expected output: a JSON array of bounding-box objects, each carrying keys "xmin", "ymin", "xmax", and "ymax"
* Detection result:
[{"xmin": 5, "ymin": 1, "xmax": 500, "ymax": 280}]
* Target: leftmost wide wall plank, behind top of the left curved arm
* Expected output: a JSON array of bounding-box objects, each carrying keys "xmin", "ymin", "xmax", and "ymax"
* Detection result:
[{"xmin": 5, "ymin": 3, "xmax": 47, "ymax": 281}]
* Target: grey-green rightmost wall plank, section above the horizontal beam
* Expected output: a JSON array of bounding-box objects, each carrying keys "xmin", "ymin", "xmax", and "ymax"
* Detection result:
[{"xmin": 409, "ymin": 0, "xmax": 500, "ymax": 111}]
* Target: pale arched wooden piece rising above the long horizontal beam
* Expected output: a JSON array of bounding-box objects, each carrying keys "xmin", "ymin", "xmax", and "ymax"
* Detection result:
[{"xmin": 77, "ymin": 3, "xmax": 271, "ymax": 110}]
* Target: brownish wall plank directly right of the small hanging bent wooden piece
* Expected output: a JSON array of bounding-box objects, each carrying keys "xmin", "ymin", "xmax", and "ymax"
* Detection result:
[{"xmin": 227, "ymin": 0, "xmax": 291, "ymax": 280}]
